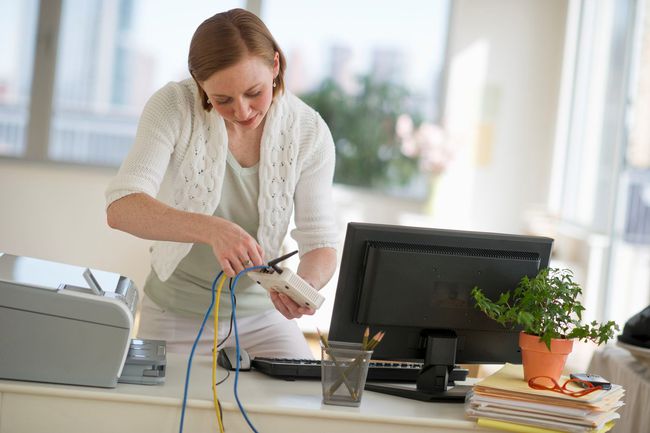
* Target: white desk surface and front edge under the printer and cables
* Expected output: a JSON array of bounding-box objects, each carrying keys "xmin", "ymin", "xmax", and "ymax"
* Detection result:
[{"xmin": 0, "ymin": 354, "xmax": 490, "ymax": 433}]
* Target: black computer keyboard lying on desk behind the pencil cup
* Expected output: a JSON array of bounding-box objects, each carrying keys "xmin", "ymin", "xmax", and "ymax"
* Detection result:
[{"xmin": 251, "ymin": 356, "xmax": 467, "ymax": 382}]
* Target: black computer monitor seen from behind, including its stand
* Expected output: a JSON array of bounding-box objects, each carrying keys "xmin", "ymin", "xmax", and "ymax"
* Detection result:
[{"xmin": 329, "ymin": 223, "xmax": 553, "ymax": 401}]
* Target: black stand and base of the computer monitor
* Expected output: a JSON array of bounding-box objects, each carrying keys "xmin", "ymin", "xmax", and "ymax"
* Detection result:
[{"xmin": 364, "ymin": 330, "xmax": 472, "ymax": 403}]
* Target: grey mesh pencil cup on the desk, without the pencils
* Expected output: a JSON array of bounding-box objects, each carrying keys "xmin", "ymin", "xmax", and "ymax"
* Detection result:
[{"xmin": 321, "ymin": 341, "xmax": 372, "ymax": 406}]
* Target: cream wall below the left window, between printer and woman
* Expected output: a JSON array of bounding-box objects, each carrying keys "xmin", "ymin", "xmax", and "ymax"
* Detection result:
[{"xmin": 0, "ymin": 159, "xmax": 149, "ymax": 287}]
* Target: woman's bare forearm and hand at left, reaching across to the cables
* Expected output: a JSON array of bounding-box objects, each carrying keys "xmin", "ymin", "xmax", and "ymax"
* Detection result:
[{"xmin": 106, "ymin": 193, "xmax": 264, "ymax": 277}]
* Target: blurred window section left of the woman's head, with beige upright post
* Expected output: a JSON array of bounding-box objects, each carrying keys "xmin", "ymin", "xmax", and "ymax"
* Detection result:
[{"xmin": 0, "ymin": 0, "xmax": 243, "ymax": 166}]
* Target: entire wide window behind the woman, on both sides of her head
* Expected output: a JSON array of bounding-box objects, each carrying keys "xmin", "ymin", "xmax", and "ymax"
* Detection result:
[{"xmin": 0, "ymin": 0, "xmax": 451, "ymax": 197}]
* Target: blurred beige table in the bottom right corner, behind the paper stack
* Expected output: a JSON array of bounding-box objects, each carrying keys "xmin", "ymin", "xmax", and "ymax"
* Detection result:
[{"xmin": 588, "ymin": 345, "xmax": 650, "ymax": 433}]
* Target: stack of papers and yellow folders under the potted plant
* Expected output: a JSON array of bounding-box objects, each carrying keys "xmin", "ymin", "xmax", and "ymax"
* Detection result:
[{"xmin": 465, "ymin": 364, "xmax": 625, "ymax": 433}]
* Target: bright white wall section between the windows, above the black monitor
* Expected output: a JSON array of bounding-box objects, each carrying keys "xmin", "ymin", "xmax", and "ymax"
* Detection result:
[{"xmin": 434, "ymin": 0, "xmax": 568, "ymax": 233}]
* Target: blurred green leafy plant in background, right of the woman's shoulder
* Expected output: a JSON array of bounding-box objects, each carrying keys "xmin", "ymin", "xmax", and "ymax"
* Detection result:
[{"xmin": 301, "ymin": 76, "xmax": 420, "ymax": 189}]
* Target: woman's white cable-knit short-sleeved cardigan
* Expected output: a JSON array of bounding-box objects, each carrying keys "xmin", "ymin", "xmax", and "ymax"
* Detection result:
[{"xmin": 106, "ymin": 80, "xmax": 338, "ymax": 281}]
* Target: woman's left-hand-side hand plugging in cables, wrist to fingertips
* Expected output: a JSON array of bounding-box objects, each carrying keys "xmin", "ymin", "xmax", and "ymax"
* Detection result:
[{"xmin": 209, "ymin": 217, "xmax": 264, "ymax": 278}]
